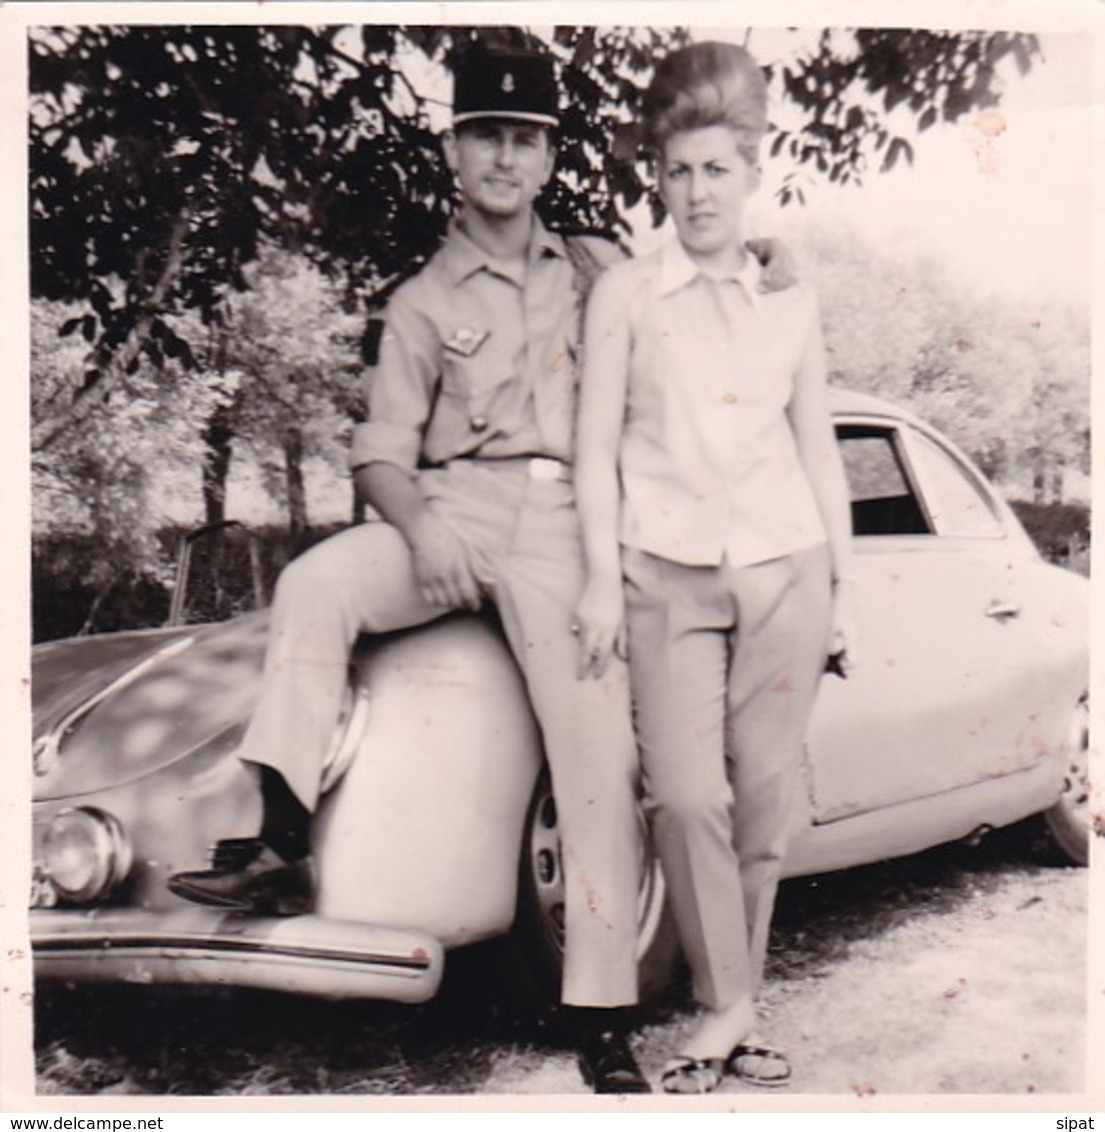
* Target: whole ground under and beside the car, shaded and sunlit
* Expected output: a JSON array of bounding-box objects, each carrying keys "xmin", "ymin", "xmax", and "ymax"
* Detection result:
[{"xmin": 36, "ymin": 830, "xmax": 1090, "ymax": 1105}]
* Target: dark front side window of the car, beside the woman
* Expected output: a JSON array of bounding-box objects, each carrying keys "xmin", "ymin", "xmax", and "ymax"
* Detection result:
[{"xmin": 837, "ymin": 425, "xmax": 933, "ymax": 537}]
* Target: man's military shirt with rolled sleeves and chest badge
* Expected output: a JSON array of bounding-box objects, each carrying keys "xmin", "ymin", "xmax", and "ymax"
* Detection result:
[{"xmin": 350, "ymin": 217, "xmax": 617, "ymax": 472}]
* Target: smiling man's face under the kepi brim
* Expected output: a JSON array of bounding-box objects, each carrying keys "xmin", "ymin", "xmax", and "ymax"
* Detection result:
[{"xmin": 445, "ymin": 118, "xmax": 555, "ymax": 216}]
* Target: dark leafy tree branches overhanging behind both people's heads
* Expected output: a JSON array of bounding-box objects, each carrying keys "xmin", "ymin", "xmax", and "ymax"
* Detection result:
[{"xmin": 28, "ymin": 25, "xmax": 1038, "ymax": 451}]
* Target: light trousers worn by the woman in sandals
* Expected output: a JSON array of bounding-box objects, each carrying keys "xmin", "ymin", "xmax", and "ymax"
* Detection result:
[{"xmin": 623, "ymin": 544, "xmax": 831, "ymax": 1007}]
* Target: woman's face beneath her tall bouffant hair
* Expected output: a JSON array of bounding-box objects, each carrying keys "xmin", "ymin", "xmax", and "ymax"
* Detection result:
[{"xmin": 660, "ymin": 126, "xmax": 760, "ymax": 261}]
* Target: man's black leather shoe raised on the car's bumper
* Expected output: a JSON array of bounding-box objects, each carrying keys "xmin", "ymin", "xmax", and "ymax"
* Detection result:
[{"xmin": 169, "ymin": 838, "xmax": 315, "ymax": 916}]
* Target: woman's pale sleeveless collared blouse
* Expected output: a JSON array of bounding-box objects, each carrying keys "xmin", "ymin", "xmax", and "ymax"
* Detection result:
[{"xmin": 610, "ymin": 241, "xmax": 825, "ymax": 566}]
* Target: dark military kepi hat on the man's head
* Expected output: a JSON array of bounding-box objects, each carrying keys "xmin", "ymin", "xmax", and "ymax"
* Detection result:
[{"xmin": 453, "ymin": 49, "xmax": 559, "ymax": 126}]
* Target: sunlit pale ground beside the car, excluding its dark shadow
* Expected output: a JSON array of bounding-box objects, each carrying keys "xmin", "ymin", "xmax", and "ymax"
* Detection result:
[{"xmin": 485, "ymin": 871, "xmax": 1087, "ymax": 1097}]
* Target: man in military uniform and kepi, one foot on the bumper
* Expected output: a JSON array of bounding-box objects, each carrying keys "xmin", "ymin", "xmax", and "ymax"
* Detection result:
[{"xmin": 170, "ymin": 52, "xmax": 649, "ymax": 1092}]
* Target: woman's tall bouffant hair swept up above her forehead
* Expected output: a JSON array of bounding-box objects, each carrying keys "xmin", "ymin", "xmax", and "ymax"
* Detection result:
[{"xmin": 642, "ymin": 42, "xmax": 768, "ymax": 165}]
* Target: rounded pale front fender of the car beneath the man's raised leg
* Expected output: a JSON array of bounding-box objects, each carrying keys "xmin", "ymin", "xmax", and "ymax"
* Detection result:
[{"xmin": 314, "ymin": 615, "xmax": 542, "ymax": 947}]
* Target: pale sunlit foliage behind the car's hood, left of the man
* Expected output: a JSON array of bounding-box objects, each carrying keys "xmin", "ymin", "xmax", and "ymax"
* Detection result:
[{"xmin": 32, "ymin": 248, "xmax": 362, "ymax": 602}]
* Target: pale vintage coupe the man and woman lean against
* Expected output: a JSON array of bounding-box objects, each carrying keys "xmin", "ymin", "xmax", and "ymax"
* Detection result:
[{"xmin": 29, "ymin": 393, "xmax": 1089, "ymax": 1002}]
